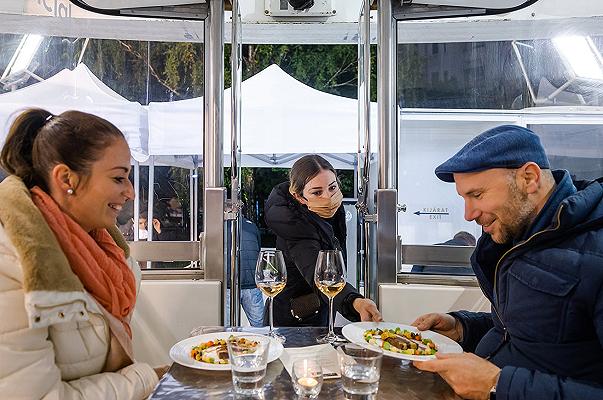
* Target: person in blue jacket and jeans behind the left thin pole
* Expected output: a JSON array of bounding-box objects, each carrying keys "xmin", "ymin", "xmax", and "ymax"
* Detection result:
[{"xmin": 224, "ymin": 206, "xmax": 264, "ymax": 327}]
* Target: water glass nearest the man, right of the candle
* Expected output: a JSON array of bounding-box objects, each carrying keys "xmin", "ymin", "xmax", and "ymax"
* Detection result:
[{"xmin": 337, "ymin": 344, "xmax": 383, "ymax": 399}]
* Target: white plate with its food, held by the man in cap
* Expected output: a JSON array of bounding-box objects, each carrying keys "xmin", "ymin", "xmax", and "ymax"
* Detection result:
[{"xmin": 341, "ymin": 322, "xmax": 463, "ymax": 361}]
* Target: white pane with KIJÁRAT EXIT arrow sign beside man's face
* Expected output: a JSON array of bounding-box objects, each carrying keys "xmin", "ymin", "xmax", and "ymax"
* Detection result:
[{"xmin": 398, "ymin": 118, "xmax": 503, "ymax": 245}]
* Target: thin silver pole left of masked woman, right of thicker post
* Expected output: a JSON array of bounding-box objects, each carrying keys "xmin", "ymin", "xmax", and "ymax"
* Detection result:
[{"xmin": 230, "ymin": 0, "xmax": 243, "ymax": 326}]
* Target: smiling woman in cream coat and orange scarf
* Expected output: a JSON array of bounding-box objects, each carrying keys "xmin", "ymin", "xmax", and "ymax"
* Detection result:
[{"xmin": 0, "ymin": 109, "xmax": 164, "ymax": 400}]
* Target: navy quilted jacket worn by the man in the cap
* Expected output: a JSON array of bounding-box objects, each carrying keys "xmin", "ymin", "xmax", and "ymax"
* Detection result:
[{"xmin": 451, "ymin": 171, "xmax": 603, "ymax": 400}]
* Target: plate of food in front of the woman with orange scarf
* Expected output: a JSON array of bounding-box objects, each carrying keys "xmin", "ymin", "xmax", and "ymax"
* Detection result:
[{"xmin": 170, "ymin": 332, "xmax": 283, "ymax": 371}]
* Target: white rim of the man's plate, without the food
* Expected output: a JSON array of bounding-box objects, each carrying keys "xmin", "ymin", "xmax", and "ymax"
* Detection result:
[{"xmin": 341, "ymin": 322, "xmax": 463, "ymax": 361}]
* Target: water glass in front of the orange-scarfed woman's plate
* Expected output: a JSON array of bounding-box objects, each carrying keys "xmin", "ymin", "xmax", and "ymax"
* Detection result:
[{"xmin": 226, "ymin": 335, "xmax": 270, "ymax": 397}]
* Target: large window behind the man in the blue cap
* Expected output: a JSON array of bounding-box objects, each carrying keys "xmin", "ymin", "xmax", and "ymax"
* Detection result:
[{"xmin": 397, "ymin": 21, "xmax": 603, "ymax": 273}]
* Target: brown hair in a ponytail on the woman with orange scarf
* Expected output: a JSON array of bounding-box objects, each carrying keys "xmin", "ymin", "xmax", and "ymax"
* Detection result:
[{"xmin": 0, "ymin": 108, "xmax": 125, "ymax": 191}]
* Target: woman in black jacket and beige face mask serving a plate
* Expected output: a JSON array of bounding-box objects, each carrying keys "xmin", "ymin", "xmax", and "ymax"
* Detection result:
[{"xmin": 265, "ymin": 154, "xmax": 381, "ymax": 326}]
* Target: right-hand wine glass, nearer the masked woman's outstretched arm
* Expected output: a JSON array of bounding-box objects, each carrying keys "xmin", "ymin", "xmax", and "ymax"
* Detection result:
[{"xmin": 314, "ymin": 250, "xmax": 345, "ymax": 343}]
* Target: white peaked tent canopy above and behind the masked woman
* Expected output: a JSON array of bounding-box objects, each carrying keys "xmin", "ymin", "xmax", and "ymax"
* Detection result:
[{"xmin": 148, "ymin": 65, "xmax": 377, "ymax": 168}]
